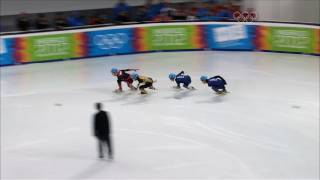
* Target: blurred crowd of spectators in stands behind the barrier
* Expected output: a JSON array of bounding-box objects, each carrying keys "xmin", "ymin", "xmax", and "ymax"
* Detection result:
[{"xmin": 16, "ymin": 0, "xmax": 240, "ymax": 31}]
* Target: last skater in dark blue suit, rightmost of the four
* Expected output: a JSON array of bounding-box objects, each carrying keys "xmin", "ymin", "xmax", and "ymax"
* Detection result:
[{"xmin": 200, "ymin": 76, "xmax": 227, "ymax": 94}]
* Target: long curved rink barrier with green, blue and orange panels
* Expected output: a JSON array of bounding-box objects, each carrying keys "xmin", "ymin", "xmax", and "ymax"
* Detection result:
[{"xmin": 0, "ymin": 22, "xmax": 320, "ymax": 66}]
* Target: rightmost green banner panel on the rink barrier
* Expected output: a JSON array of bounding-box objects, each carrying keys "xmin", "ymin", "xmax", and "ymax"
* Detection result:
[{"xmin": 267, "ymin": 27, "xmax": 315, "ymax": 53}]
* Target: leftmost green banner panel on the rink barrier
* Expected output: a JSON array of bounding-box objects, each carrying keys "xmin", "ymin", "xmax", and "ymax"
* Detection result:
[{"xmin": 27, "ymin": 34, "xmax": 76, "ymax": 62}]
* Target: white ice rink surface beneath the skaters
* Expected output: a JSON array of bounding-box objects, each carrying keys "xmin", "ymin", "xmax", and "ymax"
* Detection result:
[{"xmin": 1, "ymin": 51, "xmax": 319, "ymax": 179}]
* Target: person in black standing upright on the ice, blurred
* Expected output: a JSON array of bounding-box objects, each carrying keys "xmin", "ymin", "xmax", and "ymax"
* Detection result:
[{"xmin": 93, "ymin": 103, "xmax": 113, "ymax": 159}]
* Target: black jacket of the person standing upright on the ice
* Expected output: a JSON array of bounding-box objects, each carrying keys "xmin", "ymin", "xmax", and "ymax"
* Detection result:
[{"xmin": 93, "ymin": 111, "xmax": 111, "ymax": 138}]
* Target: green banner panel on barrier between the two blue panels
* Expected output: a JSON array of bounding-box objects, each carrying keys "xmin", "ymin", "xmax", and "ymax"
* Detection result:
[{"xmin": 145, "ymin": 25, "xmax": 195, "ymax": 50}]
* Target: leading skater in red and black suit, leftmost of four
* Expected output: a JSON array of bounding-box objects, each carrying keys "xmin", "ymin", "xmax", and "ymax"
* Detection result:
[{"xmin": 111, "ymin": 68, "xmax": 138, "ymax": 92}]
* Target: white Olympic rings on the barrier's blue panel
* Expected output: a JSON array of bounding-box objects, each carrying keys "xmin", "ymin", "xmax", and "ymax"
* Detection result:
[{"xmin": 93, "ymin": 33, "xmax": 129, "ymax": 49}]
